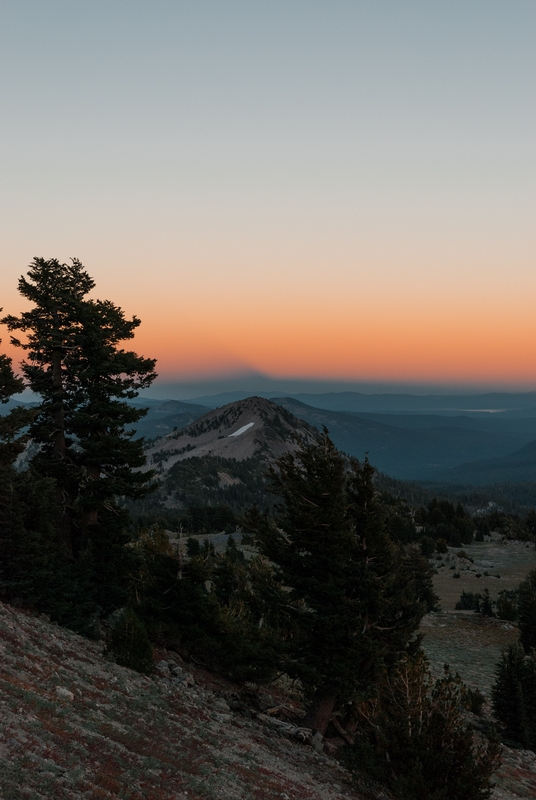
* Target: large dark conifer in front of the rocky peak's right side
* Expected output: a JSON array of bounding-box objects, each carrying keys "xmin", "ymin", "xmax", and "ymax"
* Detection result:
[{"xmin": 247, "ymin": 431, "xmax": 434, "ymax": 733}]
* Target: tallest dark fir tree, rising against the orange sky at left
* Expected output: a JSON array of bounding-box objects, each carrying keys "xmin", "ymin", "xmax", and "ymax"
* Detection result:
[{"xmin": 2, "ymin": 258, "xmax": 156, "ymax": 568}]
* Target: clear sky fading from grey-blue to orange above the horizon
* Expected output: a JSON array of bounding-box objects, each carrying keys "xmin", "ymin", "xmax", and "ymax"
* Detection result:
[{"xmin": 0, "ymin": 0, "xmax": 536, "ymax": 391}]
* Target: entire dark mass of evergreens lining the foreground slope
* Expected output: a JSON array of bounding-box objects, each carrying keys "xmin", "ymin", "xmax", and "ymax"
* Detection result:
[{"xmin": 0, "ymin": 259, "xmax": 520, "ymax": 800}]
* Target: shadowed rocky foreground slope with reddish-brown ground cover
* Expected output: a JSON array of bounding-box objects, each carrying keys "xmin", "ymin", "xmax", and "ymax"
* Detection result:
[{"xmin": 0, "ymin": 604, "xmax": 364, "ymax": 800}]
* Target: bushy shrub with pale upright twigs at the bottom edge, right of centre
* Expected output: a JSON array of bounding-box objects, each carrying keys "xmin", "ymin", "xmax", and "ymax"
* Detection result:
[{"xmin": 347, "ymin": 653, "xmax": 500, "ymax": 800}]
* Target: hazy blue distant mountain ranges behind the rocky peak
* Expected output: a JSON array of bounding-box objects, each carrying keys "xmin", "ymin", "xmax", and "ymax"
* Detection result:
[{"xmin": 6, "ymin": 392, "xmax": 536, "ymax": 486}]
